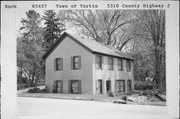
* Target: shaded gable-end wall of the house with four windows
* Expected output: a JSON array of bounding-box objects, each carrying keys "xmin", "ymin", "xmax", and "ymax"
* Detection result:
[{"xmin": 46, "ymin": 36, "xmax": 93, "ymax": 93}]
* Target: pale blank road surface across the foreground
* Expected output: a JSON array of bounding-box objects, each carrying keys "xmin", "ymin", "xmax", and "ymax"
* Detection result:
[{"xmin": 17, "ymin": 97, "xmax": 166, "ymax": 119}]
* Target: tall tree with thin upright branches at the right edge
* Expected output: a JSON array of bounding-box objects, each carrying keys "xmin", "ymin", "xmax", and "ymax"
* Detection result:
[{"xmin": 141, "ymin": 10, "xmax": 165, "ymax": 92}]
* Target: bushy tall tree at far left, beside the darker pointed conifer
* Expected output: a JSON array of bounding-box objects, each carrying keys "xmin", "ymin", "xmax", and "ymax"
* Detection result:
[{"xmin": 17, "ymin": 10, "xmax": 45, "ymax": 86}]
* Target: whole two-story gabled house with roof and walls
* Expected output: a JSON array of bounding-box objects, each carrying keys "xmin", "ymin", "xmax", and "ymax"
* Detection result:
[{"xmin": 43, "ymin": 32, "xmax": 134, "ymax": 94}]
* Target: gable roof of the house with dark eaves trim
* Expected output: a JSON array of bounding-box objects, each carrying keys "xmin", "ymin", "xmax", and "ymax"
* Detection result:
[{"xmin": 43, "ymin": 32, "xmax": 133, "ymax": 60}]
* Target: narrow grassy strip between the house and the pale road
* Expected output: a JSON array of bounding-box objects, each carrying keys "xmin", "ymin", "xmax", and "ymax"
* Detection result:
[{"xmin": 18, "ymin": 93, "xmax": 166, "ymax": 106}]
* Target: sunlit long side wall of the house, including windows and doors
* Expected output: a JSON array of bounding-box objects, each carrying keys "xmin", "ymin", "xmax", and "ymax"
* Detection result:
[{"xmin": 93, "ymin": 54, "xmax": 134, "ymax": 94}]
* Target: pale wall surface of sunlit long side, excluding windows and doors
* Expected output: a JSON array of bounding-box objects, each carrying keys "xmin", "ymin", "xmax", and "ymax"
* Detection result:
[{"xmin": 93, "ymin": 54, "xmax": 134, "ymax": 94}]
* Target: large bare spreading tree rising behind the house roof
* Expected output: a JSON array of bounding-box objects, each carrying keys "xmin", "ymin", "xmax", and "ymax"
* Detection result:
[{"xmin": 59, "ymin": 10, "xmax": 135, "ymax": 50}]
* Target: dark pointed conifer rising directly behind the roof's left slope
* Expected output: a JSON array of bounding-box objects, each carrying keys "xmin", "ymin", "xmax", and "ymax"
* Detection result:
[{"xmin": 43, "ymin": 10, "xmax": 65, "ymax": 50}]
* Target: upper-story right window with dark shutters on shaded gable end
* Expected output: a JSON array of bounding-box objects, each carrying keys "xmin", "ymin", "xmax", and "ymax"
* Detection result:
[{"xmin": 72, "ymin": 56, "xmax": 81, "ymax": 69}]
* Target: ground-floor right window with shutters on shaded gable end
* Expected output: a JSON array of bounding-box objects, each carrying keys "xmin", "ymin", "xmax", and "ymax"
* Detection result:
[{"xmin": 69, "ymin": 80, "xmax": 81, "ymax": 94}]
